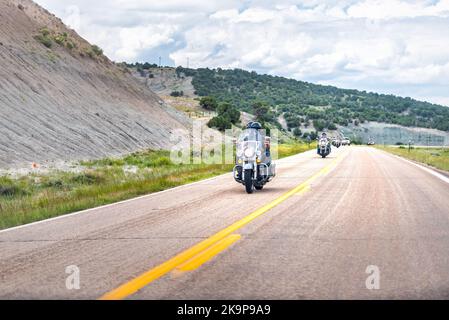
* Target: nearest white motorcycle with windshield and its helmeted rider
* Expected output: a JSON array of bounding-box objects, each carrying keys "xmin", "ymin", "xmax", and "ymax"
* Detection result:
[{"xmin": 233, "ymin": 122, "xmax": 276, "ymax": 194}]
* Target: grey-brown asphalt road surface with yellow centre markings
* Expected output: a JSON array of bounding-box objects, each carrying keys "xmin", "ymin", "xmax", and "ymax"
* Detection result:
[{"xmin": 0, "ymin": 147, "xmax": 449, "ymax": 299}]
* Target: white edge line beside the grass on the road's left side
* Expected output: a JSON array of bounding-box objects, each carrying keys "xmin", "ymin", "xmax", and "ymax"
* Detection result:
[{"xmin": 0, "ymin": 150, "xmax": 311, "ymax": 234}]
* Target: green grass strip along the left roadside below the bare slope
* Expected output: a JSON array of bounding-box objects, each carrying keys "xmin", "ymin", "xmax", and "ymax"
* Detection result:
[{"xmin": 0, "ymin": 143, "xmax": 313, "ymax": 229}]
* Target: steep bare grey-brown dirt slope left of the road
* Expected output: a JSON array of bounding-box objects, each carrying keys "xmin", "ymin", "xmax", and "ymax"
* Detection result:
[{"xmin": 0, "ymin": 0, "xmax": 189, "ymax": 168}]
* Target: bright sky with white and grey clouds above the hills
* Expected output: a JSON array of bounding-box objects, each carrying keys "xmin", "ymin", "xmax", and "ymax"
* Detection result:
[{"xmin": 37, "ymin": 0, "xmax": 449, "ymax": 106}]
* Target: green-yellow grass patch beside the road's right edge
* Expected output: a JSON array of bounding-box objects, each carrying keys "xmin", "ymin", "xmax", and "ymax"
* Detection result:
[{"xmin": 376, "ymin": 146, "xmax": 449, "ymax": 172}]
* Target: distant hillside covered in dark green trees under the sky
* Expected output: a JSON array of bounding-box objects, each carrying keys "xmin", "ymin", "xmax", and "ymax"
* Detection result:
[{"xmin": 176, "ymin": 67, "xmax": 449, "ymax": 131}]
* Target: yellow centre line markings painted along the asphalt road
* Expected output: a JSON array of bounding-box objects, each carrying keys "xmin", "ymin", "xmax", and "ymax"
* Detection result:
[{"xmin": 100, "ymin": 154, "xmax": 346, "ymax": 300}]
